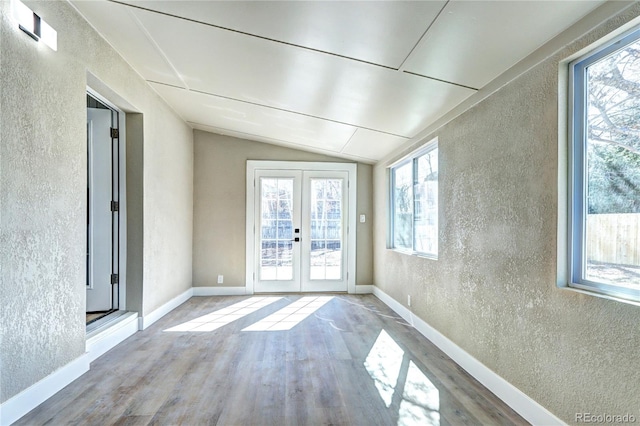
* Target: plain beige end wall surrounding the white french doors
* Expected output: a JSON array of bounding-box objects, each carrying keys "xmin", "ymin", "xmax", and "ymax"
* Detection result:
[{"xmin": 193, "ymin": 130, "xmax": 373, "ymax": 287}]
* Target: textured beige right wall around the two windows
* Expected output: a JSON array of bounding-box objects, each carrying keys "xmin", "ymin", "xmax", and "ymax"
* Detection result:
[{"xmin": 374, "ymin": 6, "xmax": 640, "ymax": 422}]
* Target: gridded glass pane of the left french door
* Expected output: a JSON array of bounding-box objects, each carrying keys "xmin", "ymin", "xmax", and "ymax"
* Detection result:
[{"xmin": 260, "ymin": 178, "xmax": 293, "ymax": 281}]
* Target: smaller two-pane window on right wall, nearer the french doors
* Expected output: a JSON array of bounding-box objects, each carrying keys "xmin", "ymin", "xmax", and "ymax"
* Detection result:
[{"xmin": 389, "ymin": 140, "xmax": 438, "ymax": 258}]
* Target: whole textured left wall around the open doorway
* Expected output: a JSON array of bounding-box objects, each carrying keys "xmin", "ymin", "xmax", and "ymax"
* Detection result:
[{"xmin": 0, "ymin": 1, "xmax": 193, "ymax": 402}]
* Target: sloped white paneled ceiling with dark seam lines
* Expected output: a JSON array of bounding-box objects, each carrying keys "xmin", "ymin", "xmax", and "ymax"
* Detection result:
[{"xmin": 71, "ymin": 0, "xmax": 604, "ymax": 163}]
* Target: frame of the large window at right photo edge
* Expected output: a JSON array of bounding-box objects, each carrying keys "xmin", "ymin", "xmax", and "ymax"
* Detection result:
[{"xmin": 565, "ymin": 27, "xmax": 640, "ymax": 304}]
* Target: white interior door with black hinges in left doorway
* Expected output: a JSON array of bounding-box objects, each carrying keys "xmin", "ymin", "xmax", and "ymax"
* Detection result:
[{"xmin": 87, "ymin": 108, "xmax": 113, "ymax": 312}]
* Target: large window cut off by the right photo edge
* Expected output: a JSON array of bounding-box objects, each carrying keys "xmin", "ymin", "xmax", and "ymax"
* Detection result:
[{"xmin": 569, "ymin": 29, "xmax": 640, "ymax": 301}]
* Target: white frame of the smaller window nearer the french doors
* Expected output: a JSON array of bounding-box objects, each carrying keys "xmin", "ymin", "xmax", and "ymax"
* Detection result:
[{"xmin": 387, "ymin": 138, "xmax": 440, "ymax": 260}]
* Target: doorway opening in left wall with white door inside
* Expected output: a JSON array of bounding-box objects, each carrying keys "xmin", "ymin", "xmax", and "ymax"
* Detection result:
[{"xmin": 86, "ymin": 93, "xmax": 124, "ymax": 330}]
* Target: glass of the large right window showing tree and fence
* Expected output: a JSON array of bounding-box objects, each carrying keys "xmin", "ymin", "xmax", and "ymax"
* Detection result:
[{"xmin": 583, "ymin": 42, "xmax": 640, "ymax": 289}]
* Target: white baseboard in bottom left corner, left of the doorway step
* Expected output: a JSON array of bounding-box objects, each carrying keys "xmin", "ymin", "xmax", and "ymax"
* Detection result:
[{"xmin": 0, "ymin": 354, "xmax": 89, "ymax": 426}]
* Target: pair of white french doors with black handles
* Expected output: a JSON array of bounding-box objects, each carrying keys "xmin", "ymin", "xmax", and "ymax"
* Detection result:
[{"xmin": 246, "ymin": 162, "xmax": 353, "ymax": 293}]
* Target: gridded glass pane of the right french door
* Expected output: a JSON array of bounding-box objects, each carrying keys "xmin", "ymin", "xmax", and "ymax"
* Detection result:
[{"xmin": 309, "ymin": 178, "xmax": 343, "ymax": 280}]
